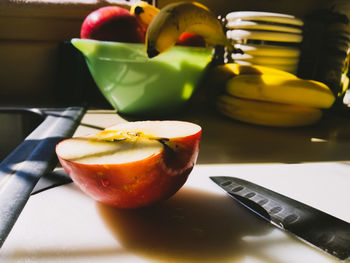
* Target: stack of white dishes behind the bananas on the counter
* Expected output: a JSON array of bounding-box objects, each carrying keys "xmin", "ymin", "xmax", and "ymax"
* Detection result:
[{"xmin": 226, "ymin": 11, "xmax": 304, "ymax": 74}]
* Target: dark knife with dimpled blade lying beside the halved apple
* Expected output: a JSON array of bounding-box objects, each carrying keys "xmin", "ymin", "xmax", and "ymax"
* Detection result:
[{"xmin": 210, "ymin": 176, "xmax": 350, "ymax": 261}]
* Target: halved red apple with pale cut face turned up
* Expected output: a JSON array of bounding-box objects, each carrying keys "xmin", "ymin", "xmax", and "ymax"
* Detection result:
[{"xmin": 56, "ymin": 121, "xmax": 202, "ymax": 208}]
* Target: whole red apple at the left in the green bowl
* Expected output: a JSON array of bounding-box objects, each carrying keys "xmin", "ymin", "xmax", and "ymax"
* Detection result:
[{"xmin": 80, "ymin": 6, "xmax": 145, "ymax": 43}]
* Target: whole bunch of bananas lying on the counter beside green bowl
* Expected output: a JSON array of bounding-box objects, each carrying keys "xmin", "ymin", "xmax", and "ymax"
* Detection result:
[{"xmin": 210, "ymin": 63, "xmax": 335, "ymax": 127}]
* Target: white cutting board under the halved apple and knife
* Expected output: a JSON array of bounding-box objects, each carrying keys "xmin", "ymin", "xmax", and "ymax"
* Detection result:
[{"xmin": 0, "ymin": 163, "xmax": 350, "ymax": 263}]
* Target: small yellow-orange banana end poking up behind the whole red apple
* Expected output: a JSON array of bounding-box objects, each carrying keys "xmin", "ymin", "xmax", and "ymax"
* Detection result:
[{"xmin": 130, "ymin": 1, "xmax": 160, "ymax": 28}]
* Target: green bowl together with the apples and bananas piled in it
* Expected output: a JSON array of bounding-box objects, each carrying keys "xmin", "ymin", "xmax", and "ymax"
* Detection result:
[{"xmin": 71, "ymin": 2, "xmax": 228, "ymax": 116}]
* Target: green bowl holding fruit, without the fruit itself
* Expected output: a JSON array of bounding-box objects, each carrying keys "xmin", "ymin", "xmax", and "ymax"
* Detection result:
[{"xmin": 71, "ymin": 38, "xmax": 212, "ymax": 116}]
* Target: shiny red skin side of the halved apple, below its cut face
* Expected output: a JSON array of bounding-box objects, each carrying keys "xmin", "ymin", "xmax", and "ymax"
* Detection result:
[{"xmin": 58, "ymin": 131, "xmax": 201, "ymax": 209}]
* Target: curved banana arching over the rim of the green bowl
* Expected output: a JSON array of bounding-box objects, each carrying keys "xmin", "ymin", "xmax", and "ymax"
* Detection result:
[{"xmin": 146, "ymin": 2, "xmax": 232, "ymax": 58}]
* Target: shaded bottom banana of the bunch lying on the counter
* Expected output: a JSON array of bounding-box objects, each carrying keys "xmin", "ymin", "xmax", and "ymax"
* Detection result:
[{"xmin": 216, "ymin": 95, "xmax": 322, "ymax": 127}]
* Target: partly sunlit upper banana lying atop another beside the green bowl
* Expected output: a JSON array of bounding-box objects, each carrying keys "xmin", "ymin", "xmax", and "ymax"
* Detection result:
[{"xmin": 226, "ymin": 74, "xmax": 335, "ymax": 108}]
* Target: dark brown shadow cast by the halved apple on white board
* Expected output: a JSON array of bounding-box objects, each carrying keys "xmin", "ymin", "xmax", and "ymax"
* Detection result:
[{"xmin": 96, "ymin": 188, "xmax": 272, "ymax": 263}]
